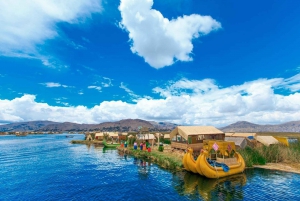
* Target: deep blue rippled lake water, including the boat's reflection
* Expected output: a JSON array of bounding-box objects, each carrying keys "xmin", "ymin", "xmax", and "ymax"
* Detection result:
[{"xmin": 0, "ymin": 134, "xmax": 300, "ymax": 201}]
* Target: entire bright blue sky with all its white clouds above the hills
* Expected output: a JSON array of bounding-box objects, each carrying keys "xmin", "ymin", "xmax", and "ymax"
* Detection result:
[{"xmin": 0, "ymin": 0, "xmax": 300, "ymax": 127}]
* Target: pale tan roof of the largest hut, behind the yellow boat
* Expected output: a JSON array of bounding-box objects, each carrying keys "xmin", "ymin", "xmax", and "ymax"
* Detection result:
[{"xmin": 170, "ymin": 126, "xmax": 224, "ymax": 139}]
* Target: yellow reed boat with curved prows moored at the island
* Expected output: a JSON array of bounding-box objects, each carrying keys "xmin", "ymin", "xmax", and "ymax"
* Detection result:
[{"xmin": 182, "ymin": 141, "xmax": 245, "ymax": 178}]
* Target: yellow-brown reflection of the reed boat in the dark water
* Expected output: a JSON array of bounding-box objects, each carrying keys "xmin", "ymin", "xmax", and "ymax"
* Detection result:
[{"xmin": 173, "ymin": 172, "xmax": 247, "ymax": 200}]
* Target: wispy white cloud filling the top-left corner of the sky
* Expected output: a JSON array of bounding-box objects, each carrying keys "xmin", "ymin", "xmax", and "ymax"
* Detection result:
[{"xmin": 0, "ymin": 0, "xmax": 101, "ymax": 60}]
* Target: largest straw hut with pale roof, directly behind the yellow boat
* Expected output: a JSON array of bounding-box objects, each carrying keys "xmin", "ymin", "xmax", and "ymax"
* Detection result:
[{"xmin": 170, "ymin": 126, "xmax": 225, "ymax": 152}]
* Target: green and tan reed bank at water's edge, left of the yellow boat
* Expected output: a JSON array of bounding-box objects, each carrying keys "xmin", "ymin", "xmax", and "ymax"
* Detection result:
[{"xmin": 117, "ymin": 146, "xmax": 183, "ymax": 172}]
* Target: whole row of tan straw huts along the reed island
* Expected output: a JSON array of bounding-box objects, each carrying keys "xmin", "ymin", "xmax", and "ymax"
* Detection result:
[{"xmin": 87, "ymin": 126, "xmax": 289, "ymax": 152}]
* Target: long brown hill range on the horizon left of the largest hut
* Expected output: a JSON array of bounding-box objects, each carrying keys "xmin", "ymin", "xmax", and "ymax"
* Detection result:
[{"xmin": 0, "ymin": 119, "xmax": 177, "ymax": 132}]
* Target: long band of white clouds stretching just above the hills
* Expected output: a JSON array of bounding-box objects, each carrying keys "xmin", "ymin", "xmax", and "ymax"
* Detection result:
[{"xmin": 0, "ymin": 74, "xmax": 300, "ymax": 127}]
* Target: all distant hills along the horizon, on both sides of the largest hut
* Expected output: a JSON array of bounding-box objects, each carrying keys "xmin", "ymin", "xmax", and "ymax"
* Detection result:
[{"xmin": 0, "ymin": 119, "xmax": 300, "ymax": 132}]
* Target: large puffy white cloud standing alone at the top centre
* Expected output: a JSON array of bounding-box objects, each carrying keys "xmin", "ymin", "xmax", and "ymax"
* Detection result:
[{"xmin": 119, "ymin": 0, "xmax": 221, "ymax": 68}]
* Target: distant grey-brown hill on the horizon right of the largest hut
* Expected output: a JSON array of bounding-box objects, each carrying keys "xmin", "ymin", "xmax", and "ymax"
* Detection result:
[{"xmin": 220, "ymin": 121, "xmax": 300, "ymax": 132}]
